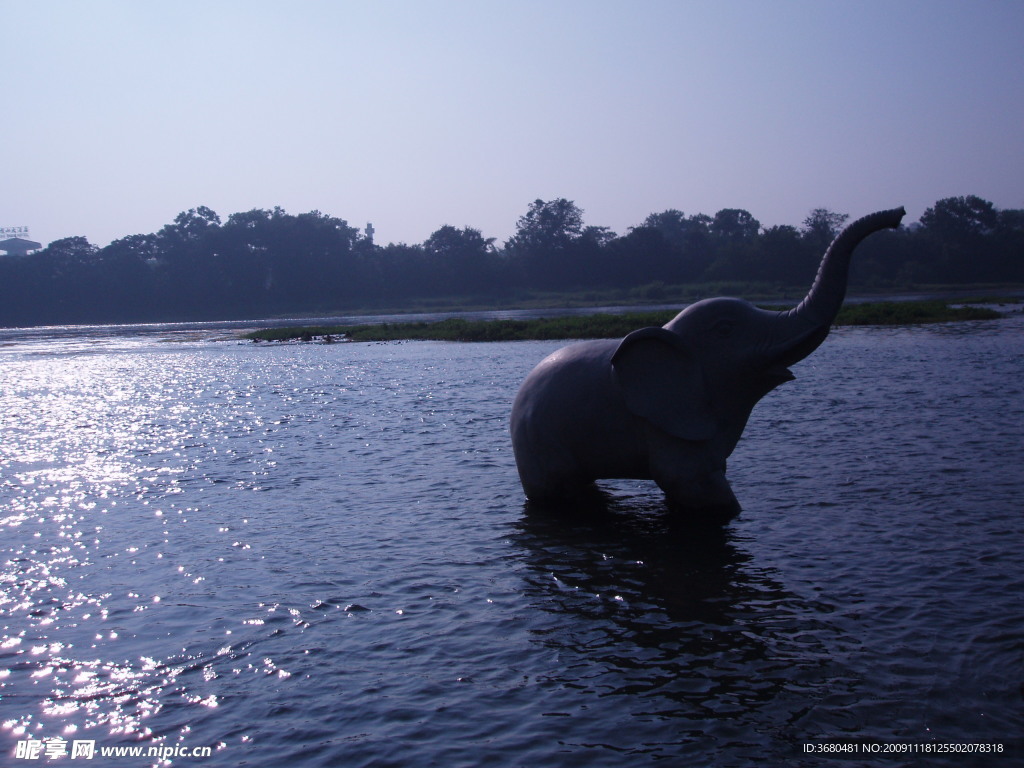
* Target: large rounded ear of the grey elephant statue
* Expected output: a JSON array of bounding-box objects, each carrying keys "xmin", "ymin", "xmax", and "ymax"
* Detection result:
[{"xmin": 611, "ymin": 328, "xmax": 716, "ymax": 440}]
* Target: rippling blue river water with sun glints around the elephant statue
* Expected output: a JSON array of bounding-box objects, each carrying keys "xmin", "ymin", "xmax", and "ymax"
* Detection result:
[{"xmin": 0, "ymin": 316, "xmax": 1024, "ymax": 767}]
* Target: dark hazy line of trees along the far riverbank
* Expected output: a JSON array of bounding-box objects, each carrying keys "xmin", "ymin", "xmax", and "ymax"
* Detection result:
[{"xmin": 0, "ymin": 196, "xmax": 1024, "ymax": 327}]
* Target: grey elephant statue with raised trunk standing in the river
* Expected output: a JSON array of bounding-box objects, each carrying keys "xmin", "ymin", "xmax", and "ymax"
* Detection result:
[{"xmin": 511, "ymin": 207, "xmax": 905, "ymax": 522}]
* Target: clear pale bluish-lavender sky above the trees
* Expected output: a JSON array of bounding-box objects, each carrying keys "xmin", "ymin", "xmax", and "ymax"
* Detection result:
[{"xmin": 0, "ymin": 0, "xmax": 1024, "ymax": 246}]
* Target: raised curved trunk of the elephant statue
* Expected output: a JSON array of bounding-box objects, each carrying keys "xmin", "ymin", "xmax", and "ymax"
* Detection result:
[{"xmin": 779, "ymin": 206, "xmax": 906, "ymax": 366}]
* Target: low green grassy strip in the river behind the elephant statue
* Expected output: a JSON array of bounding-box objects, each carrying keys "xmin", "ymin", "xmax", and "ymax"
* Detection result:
[{"xmin": 243, "ymin": 300, "xmax": 1001, "ymax": 343}]
